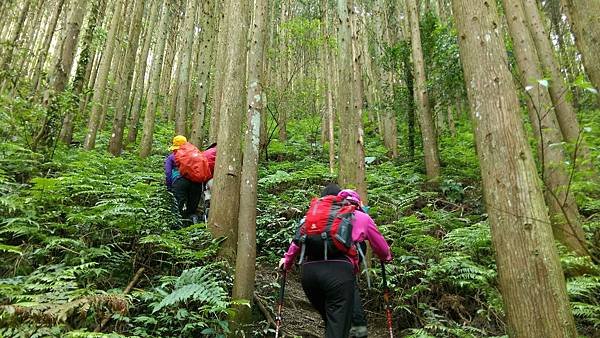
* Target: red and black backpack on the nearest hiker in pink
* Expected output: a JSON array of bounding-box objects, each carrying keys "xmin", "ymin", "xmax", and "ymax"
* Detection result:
[{"xmin": 294, "ymin": 196, "xmax": 357, "ymax": 264}]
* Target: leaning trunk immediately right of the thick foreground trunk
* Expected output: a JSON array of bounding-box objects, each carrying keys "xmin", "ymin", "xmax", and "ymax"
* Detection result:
[{"xmin": 503, "ymin": 0, "xmax": 589, "ymax": 255}]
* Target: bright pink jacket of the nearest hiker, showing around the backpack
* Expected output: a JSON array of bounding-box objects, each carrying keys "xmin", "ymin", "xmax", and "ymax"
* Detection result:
[{"xmin": 284, "ymin": 210, "xmax": 392, "ymax": 271}]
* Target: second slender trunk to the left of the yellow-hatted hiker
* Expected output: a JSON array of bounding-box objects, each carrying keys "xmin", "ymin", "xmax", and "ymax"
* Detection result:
[{"xmin": 108, "ymin": 0, "xmax": 145, "ymax": 156}]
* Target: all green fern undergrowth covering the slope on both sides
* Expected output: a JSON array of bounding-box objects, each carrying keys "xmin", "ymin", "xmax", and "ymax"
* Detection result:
[{"xmin": 0, "ymin": 100, "xmax": 600, "ymax": 337}]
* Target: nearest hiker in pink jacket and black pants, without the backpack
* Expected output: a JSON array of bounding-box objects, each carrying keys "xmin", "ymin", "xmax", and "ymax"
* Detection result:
[{"xmin": 279, "ymin": 185, "xmax": 392, "ymax": 338}]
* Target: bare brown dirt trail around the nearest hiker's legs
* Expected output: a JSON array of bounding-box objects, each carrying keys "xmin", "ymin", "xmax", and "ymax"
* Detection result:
[{"xmin": 255, "ymin": 266, "xmax": 389, "ymax": 338}]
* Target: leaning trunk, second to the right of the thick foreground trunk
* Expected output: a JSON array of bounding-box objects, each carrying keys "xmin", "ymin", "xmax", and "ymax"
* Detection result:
[{"xmin": 522, "ymin": 0, "xmax": 600, "ymax": 171}]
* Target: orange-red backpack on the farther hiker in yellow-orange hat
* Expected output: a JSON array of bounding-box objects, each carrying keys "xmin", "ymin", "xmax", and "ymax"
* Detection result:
[{"xmin": 175, "ymin": 142, "xmax": 215, "ymax": 183}]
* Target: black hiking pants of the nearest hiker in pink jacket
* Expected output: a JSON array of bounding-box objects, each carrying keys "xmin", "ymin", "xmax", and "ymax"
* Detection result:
[{"xmin": 302, "ymin": 260, "xmax": 355, "ymax": 338}]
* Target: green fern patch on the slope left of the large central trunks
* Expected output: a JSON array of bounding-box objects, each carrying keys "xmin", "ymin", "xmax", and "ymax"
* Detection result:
[{"xmin": 0, "ymin": 143, "xmax": 226, "ymax": 337}]
